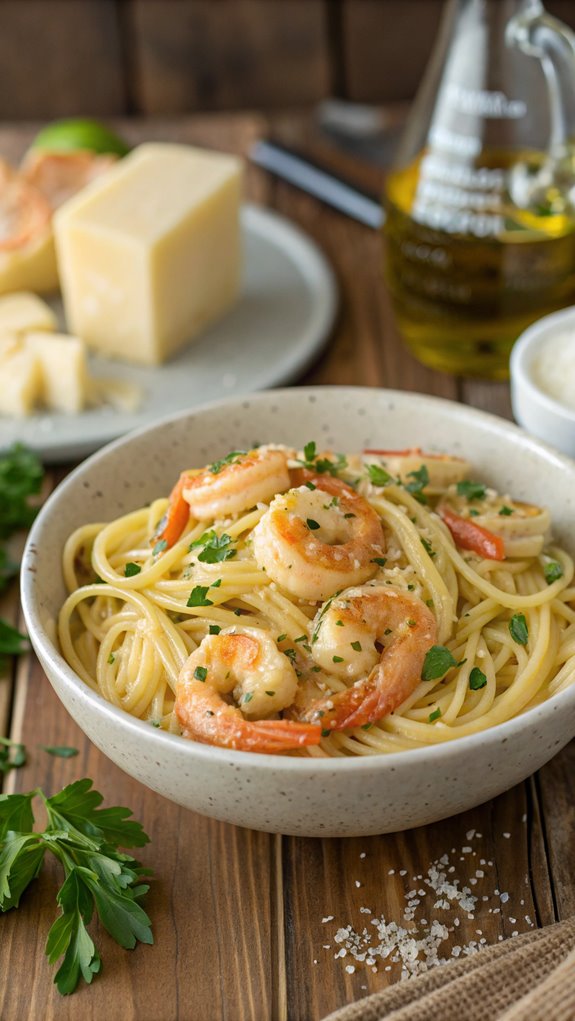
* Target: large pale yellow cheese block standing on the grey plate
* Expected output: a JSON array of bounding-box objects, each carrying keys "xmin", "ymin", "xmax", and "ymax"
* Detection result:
[{"xmin": 54, "ymin": 144, "xmax": 242, "ymax": 364}]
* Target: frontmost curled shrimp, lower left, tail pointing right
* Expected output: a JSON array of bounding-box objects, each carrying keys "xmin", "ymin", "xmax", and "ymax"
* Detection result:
[{"xmin": 175, "ymin": 628, "xmax": 321, "ymax": 752}]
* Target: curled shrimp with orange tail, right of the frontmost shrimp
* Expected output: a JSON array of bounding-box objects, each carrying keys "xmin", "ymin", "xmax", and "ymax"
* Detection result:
[{"xmin": 303, "ymin": 585, "xmax": 437, "ymax": 730}]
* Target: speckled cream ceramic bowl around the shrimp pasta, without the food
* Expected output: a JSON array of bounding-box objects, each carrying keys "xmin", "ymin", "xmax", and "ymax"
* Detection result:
[{"xmin": 22, "ymin": 387, "xmax": 575, "ymax": 836}]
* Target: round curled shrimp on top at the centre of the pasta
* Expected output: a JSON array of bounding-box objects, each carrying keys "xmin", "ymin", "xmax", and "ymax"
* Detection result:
[{"xmin": 253, "ymin": 472, "xmax": 385, "ymax": 600}]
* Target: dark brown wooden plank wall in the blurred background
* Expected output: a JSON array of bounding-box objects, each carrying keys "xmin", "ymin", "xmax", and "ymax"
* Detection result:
[{"xmin": 0, "ymin": 0, "xmax": 575, "ymax": 120}]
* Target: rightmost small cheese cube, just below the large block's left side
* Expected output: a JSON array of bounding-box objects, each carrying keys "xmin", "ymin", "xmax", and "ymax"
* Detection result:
[{"xmin": 23, "ymin": 333, "xmax": 88, "ymax": 415}]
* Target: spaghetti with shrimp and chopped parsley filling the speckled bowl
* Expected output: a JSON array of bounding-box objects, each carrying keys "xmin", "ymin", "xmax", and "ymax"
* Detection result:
[{"xmin": 58, "ymin": 444, "xmax": 575, "ymax": 757}]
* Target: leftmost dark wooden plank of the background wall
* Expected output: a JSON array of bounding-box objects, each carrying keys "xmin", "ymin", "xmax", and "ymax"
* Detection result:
[{"xmin": 0, "ymin": 0, "xmax": 125, "ymax": 119}]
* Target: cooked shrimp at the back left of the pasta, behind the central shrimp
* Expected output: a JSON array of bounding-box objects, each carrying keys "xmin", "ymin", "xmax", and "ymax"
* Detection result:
[{"xmin": 183, "ymin": 447, "xmax": 290, "ymax": 521}]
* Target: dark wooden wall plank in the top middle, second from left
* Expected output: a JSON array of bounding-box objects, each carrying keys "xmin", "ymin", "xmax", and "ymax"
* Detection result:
[{"xmin": 131, "ymin": 0, "xmax": 329, "ymax": 114}]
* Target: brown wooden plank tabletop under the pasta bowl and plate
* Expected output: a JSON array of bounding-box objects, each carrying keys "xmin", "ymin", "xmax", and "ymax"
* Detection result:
[{"xmin": 0, "ymin": 114, "xmax": 575, "ymax": 1021}]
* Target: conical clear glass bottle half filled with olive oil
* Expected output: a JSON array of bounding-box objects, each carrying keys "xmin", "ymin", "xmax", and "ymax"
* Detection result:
[{"xmin": 384, "ymin": 0, "xmax": 575, "ymax": 379}]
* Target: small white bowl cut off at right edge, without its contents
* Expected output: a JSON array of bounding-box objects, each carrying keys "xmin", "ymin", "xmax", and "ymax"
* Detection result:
[{"xmin": 510, "ymin": 307, "xmax": 575, "ymax": 457}]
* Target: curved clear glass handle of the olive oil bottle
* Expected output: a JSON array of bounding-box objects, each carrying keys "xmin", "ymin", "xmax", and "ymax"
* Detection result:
[{"xmin": 506, "ymin": 2, "xmax": 575, "ymax": 156}]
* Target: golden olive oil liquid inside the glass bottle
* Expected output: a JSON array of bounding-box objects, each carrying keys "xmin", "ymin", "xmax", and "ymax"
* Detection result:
[{"xmin": 385, "ymin": 150, "xmax": 575, "ymax": 379}]
